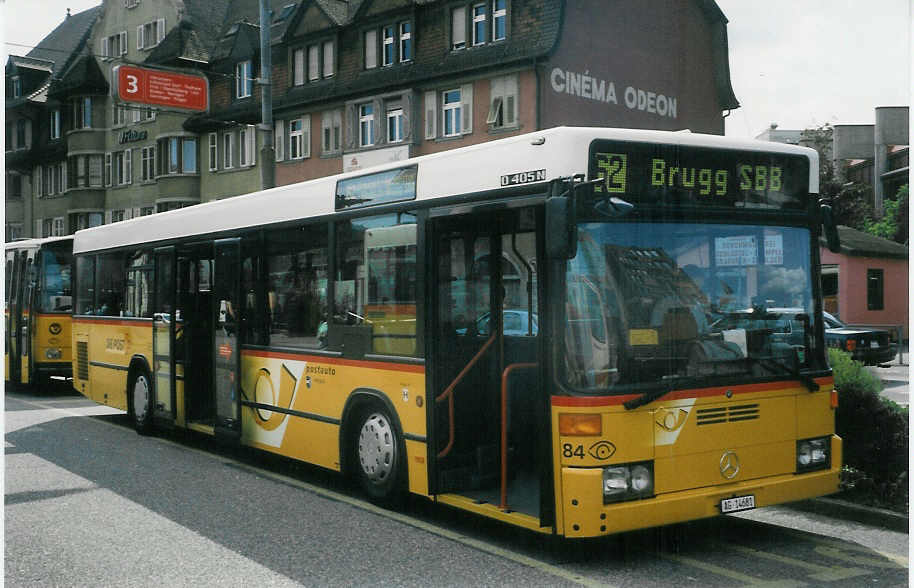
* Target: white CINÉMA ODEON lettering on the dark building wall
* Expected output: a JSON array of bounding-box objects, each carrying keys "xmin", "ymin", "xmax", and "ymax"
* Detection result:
[{"xmin": 549, "ymin": 67, "xmax": 678, "ymax": 118}]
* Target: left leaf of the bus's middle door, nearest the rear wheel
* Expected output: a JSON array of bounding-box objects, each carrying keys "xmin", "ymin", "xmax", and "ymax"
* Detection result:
[{"xmin": 152, "ymin": 247, "xmax": 175, "ymax": 424}]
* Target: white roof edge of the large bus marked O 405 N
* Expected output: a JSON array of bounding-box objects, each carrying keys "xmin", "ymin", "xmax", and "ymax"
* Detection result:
[{"xmin": 73, "ymin": 127, "xmax": 819, "ymax": 253}]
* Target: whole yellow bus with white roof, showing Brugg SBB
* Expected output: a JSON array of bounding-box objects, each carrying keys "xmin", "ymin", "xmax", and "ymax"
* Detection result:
[{"xmin": 73, "ymin": 128, "xmax": 842, "ymax": 537}]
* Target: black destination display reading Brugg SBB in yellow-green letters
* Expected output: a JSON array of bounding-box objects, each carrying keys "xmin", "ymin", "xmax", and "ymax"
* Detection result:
[{"xmin": 588, "ymin": 141, "xmax": 809, "ymax": 210}]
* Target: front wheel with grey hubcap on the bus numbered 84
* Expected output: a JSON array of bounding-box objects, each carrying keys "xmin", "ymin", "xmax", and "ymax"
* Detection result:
[{"xmin": 351, "ymin": 407, "xmax": 406, "ymax": 504}]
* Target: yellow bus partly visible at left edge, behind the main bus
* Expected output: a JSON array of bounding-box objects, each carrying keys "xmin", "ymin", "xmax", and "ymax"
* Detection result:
[{"xmin": 3, "ymin": 237, "xmax": 73, "ymax": 387}]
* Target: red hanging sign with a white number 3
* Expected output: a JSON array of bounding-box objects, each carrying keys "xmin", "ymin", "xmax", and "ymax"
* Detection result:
[{"xmin": 115, "ymin": 65, "xmax": 209, "ymax": 112}]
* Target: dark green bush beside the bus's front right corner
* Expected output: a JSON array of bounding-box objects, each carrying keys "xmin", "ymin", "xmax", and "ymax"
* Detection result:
[{"xmin": 828, "ymin": 349, "xmax": 908, "ymax": 510}]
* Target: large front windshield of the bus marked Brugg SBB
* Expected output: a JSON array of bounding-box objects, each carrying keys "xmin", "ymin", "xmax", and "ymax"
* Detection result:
[{"xmin": 559, "ymin": 223, "xmax": 815, "ymax": 393}]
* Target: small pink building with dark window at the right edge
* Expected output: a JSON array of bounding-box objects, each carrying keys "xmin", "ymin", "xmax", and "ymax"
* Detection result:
[{"xmin": 820, "ymin": 226, "xmax": 908, "ymax": 339}]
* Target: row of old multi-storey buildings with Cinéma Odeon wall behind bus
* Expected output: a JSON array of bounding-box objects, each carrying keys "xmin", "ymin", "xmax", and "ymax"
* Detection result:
[{"xmin": 7, "ymin": 0, "xmax": 738, "ymax": 238}]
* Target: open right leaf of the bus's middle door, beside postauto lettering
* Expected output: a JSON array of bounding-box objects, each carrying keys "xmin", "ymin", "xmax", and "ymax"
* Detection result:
[{"xmin": 213, "ymin": 239, "xmax": 241, "ymax": 439}]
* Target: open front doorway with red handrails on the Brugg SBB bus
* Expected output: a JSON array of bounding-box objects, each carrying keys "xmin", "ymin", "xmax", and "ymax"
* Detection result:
[{"xmin": 429, "ymin": 208, "xmax": 548, "ymax": 520}]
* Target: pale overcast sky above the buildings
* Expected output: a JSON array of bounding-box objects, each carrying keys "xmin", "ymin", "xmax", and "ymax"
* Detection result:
[{"xmin": 0, "ymin": 0, "xmax": 914, "ymax": 137}]
